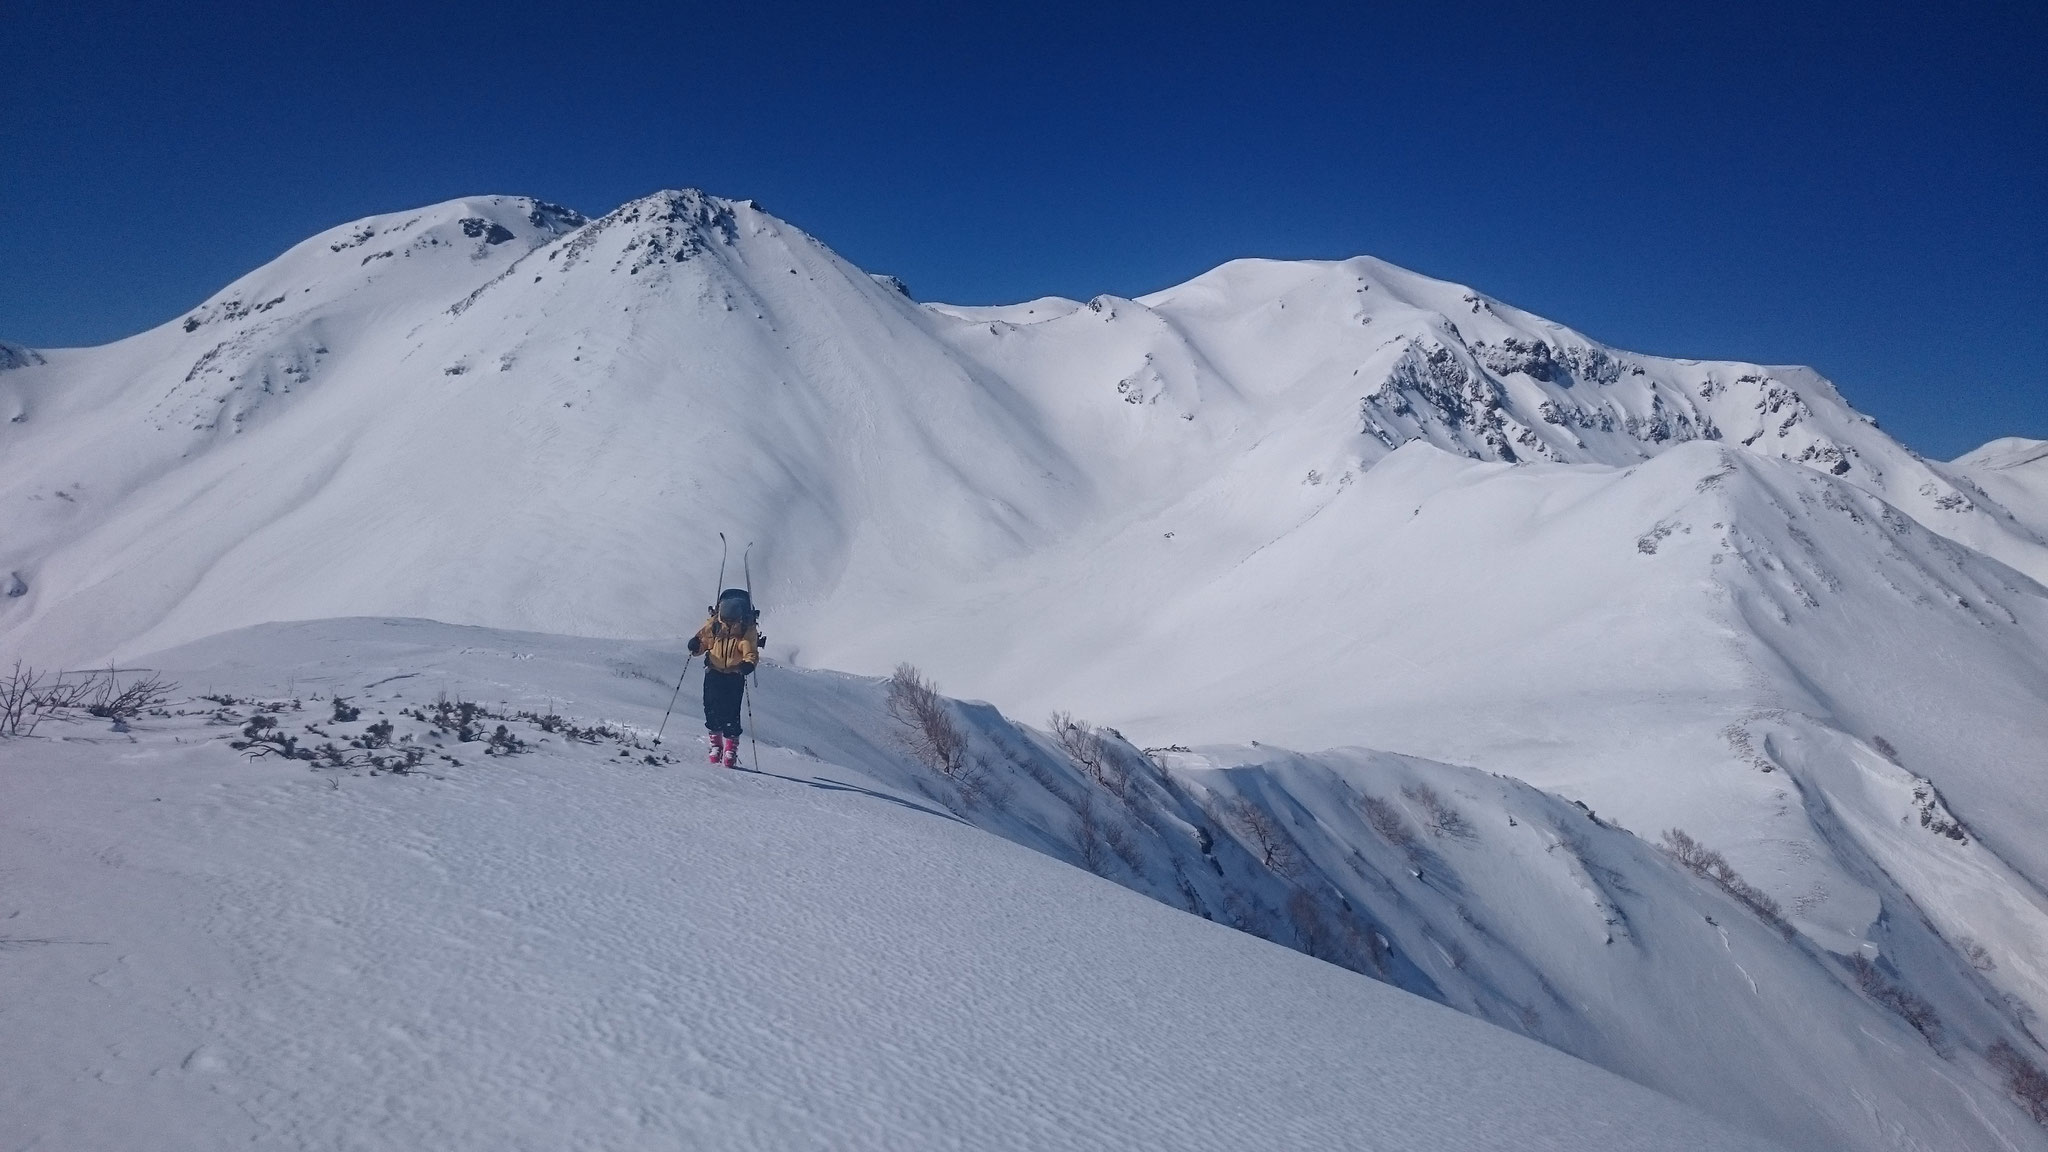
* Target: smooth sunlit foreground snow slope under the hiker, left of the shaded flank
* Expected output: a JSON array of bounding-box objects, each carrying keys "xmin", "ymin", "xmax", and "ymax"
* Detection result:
[{"xmin": 0, "ymin": 621, "xmax": 1767, "ymax": 1152}]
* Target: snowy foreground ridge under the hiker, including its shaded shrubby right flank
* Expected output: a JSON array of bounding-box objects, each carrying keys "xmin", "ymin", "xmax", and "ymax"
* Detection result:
[{"xmin": 0, "ymin": 619, "xmax": 2048, "ymax": 1150}]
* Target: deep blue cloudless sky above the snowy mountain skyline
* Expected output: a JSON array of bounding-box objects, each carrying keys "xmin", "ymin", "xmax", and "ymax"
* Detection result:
[{"xmin": 0, "ymin": 0, "xmax": 2048, "ymax": 457}]
